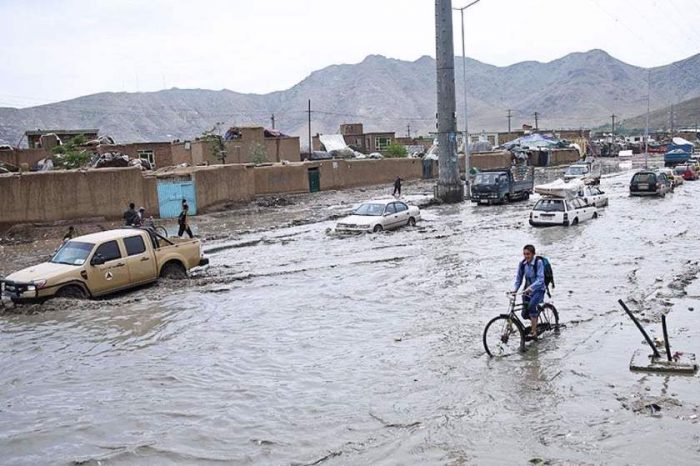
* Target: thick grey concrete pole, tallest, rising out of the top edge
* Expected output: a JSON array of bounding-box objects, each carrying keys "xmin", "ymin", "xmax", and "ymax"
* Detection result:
[{"xmin": 435, "ymin": 0, "xmax": 468, "ymax": 202}]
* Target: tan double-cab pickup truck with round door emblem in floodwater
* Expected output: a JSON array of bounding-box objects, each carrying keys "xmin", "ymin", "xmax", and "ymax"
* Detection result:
[{"xmin": 0, "ymin": 228, "xmax": 209, "ymax": 302}]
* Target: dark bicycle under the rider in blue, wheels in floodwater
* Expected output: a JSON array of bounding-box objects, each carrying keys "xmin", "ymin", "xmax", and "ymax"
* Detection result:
[{"xmin": 483, "ymin": 292, "xmax": 559, "ymax": 357}]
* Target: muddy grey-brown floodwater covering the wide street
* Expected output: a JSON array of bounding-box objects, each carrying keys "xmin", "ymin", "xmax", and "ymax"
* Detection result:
[{"xmin": 0, "ymin": 158, "xmax": 700, "ymax": 465}]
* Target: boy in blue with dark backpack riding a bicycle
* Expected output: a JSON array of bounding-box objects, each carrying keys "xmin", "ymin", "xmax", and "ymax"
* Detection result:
[{"xmin": 513, "ymin": 244, "xmax": 546, "ymax": 340}]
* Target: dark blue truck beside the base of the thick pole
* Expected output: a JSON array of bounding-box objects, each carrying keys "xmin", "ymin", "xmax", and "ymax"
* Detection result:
[{"xmin": 471, "ymin": 165, "xmax": 535, "ymax": 204}]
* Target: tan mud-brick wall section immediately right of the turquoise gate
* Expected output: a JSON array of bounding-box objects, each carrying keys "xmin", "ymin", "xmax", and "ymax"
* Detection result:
[{"xmin": 192, "ymin": 165, "xmax": 256, "ymax": 211}]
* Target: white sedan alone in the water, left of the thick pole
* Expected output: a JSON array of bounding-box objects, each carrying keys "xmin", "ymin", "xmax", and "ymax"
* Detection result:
[{"xmin": 335, "ymin": 199, "xmax": 420, "ymax": 233}]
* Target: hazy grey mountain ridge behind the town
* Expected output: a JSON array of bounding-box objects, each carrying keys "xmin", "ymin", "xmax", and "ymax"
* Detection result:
[{"xmin": 0, "ymin": 50, "xmax": 700, "ymax": 146}]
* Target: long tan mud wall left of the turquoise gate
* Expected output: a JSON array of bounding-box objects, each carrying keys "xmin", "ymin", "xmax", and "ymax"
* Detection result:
[{"xmin": 0, "ymin": 167, "xmax": 158, "ymax": 224}]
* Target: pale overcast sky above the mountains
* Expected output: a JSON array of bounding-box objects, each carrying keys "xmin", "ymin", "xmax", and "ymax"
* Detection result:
[{"xmin": 0, "ymin": 0, "xmax": 700, "ymax": 107}]
